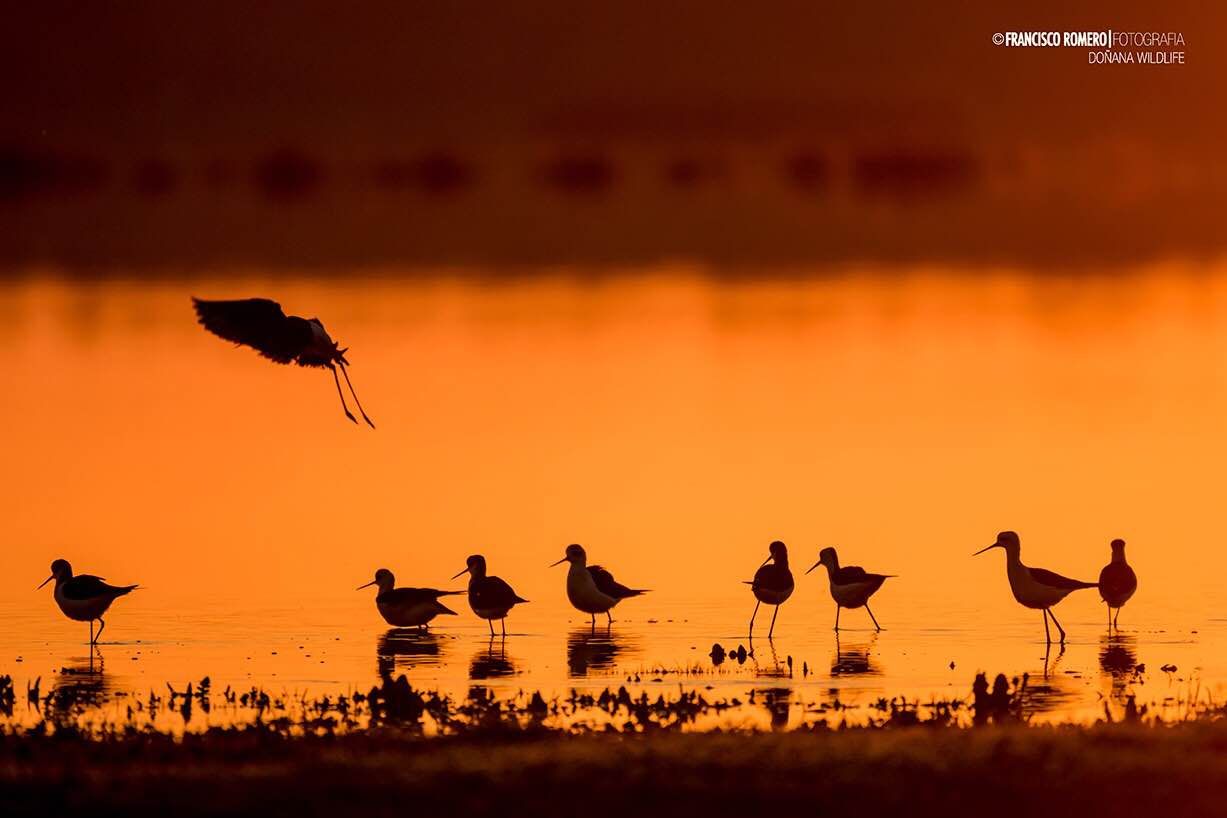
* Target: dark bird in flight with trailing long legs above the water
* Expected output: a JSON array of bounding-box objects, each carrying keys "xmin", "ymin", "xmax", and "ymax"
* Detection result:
[{"xmin": 191, "ymin": 298, "xmax": 375, "ymax": 429}]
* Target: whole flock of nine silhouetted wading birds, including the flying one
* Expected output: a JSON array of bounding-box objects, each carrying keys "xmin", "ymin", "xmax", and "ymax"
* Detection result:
[{"xmin": 38, "ymin": 298, "xmax": 1137, "ymax": 645}]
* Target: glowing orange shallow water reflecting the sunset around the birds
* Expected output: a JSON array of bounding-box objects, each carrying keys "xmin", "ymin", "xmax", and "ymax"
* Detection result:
[{"xmin": 0, "ymin": 265, "xmax": 1227, "ymax": 727}]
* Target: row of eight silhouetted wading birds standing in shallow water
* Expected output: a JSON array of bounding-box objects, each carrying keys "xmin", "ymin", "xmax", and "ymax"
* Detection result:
[{"xmin": 39, "ymin": 531, "xmax": 1137, "ymax": 645}]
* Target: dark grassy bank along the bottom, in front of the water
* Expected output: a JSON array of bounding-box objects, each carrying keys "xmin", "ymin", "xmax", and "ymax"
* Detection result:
[{"xmin": 0, "ymin": 721, "xmax": 1227, "ymax": 818}]
